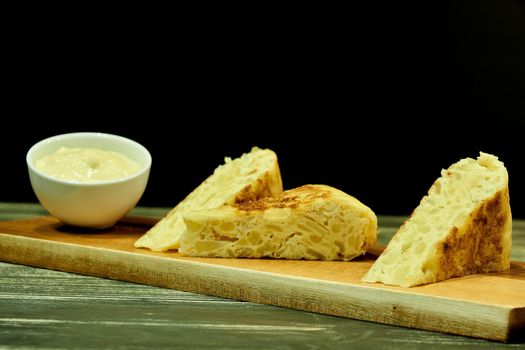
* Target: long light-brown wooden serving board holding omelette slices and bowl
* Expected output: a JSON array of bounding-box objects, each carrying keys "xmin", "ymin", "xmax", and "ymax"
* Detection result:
[{"xmin": 0, "ymin": 217, "xmax": 525, "ymax": 341}]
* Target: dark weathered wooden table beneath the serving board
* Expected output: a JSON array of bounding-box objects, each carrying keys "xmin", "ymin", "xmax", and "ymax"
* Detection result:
[{"xmin": 0, "ymin": 203, "xmax": 525, "ymax": 350}]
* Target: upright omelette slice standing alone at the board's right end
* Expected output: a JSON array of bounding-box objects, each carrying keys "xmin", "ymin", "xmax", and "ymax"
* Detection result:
[{"xmin": 363, "ymin": 152, "xmax": 512, "ymax": 287}]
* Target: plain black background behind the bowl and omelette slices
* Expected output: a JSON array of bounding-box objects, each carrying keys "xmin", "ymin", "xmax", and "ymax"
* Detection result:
[{"xmin": 4, "ymin": 0, "xmax": 525, "ymax": 218}]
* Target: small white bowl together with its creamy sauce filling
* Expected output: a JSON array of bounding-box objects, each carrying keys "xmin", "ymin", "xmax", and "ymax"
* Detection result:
[{"xmin": 26, "ymin": 132, "xmax": 151, "ymax": 229}]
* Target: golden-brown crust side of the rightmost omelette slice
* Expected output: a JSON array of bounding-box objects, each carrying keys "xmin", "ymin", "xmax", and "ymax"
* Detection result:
[{"xmin": 437, "ymin": 189, "xmax": 512, "ymax": 281}]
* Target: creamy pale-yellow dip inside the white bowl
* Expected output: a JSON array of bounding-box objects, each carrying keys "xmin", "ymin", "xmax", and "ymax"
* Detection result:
[{"xmin": 35, "ymin": 147, "xmax": 140, "ymax": 182}]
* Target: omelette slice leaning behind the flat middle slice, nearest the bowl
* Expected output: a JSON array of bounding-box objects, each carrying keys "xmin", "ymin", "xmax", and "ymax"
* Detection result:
[{"xmin": 135, "ymin": 147, "xmax": 283, "ymax": 251}]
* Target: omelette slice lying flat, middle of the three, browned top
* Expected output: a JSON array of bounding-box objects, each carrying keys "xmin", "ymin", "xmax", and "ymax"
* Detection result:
[{"xmin": 179, "ymin": 185, "xmax": 377, "ymax": 260}]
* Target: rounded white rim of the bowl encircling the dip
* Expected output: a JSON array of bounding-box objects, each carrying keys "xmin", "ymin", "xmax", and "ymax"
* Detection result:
[{"xmin": 26, "ymin": 131, "xmax": 152, "ymax": 187}]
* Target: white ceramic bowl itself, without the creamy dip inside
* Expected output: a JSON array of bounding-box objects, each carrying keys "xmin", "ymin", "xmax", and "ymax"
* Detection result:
[{"xmin": 26, "ymin": 132, "xmax": 151, "ymax": 228}]
